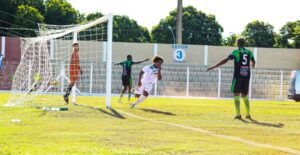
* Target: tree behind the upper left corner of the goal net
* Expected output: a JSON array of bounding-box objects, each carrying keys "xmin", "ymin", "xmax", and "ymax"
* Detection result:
[{"xmin": 10, "ymin": 5, "xmax": 44, "ymax": 37}]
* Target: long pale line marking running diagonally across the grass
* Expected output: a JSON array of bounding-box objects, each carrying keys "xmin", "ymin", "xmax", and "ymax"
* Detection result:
[{"xmin": 118, "ymin": 109, "xmax": 300, "ymax": 155}]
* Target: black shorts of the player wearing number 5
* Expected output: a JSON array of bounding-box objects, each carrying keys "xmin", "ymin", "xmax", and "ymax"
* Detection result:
[{"xmin": 231, "ymin": 78, "xmax": 250, "ymax": 94}]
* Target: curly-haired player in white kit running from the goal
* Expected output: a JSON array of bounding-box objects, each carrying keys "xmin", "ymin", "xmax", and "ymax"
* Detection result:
[{"xmin": 130, "ymin": 56, "xmax": 164, "ymax": 108}]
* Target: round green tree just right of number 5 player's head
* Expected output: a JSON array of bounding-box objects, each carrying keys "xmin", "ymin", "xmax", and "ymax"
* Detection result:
[{"xmin": 242, "ymin": 21, "xmax": 275, "ymax": 47}]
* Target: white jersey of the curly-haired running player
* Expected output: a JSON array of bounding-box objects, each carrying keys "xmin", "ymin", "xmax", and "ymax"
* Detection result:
[{"xmin": 141, "ymin": 64, "xmax": 159, "ymax": 84}]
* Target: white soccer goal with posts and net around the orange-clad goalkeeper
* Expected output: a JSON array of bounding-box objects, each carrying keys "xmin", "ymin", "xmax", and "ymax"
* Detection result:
[{"xmin": 7, "ymin": 15, "xmax": 112, "ymax": 107}]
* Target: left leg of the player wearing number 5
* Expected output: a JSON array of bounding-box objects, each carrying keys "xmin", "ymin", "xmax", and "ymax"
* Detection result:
[{"xmin": 231, "ymin": 78, "xmax": 242, "ymax": 119}]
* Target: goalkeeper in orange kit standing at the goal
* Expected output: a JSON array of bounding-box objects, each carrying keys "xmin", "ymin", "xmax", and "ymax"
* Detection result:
[{"xmin": 63, "ymin": 42, "xmax": 82, "ymax": 104}]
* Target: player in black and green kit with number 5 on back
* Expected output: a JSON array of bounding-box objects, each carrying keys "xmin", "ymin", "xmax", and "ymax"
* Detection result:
[{"xmin": 207, "ymin": 38, "xmax": 255, "ymax": 120}]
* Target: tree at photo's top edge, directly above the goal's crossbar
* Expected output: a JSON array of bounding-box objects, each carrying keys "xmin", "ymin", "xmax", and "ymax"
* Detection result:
[{"xmin": 45, "ymin": 0, "xmax": 81, "ymax": 25}]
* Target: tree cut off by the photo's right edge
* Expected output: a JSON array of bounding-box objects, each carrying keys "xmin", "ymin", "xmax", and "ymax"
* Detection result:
[{"xmin": 279, "ymin": 20, "xmax": 300, "ymax": 48}]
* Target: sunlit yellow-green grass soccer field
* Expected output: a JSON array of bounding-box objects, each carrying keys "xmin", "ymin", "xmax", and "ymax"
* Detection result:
[{"xmin": 0, "ymin": 93, "xmax": 300, "ymax": 155}]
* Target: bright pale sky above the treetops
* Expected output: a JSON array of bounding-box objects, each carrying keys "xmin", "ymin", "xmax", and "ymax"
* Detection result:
[{"xmin": 67, "ymin": 0, "xmax": 300, "ymax": 36}]
